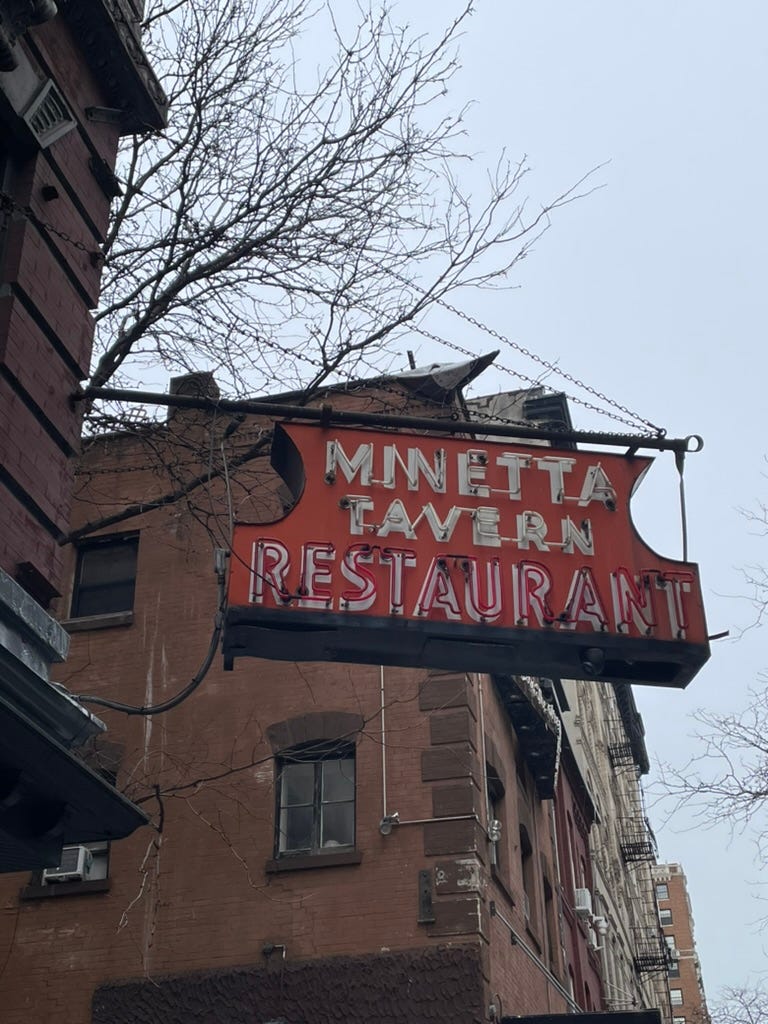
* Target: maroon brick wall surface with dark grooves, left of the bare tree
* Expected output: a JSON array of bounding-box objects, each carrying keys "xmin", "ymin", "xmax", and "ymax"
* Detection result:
[{"xmin": 0, "ymin": 16, "xmax": 123, "ymax": 589}]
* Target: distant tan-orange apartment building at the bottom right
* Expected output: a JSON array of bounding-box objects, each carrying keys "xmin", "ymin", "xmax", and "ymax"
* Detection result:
[{"xmin": 652, "ymin": 863, "xmax": 710, "ymax": 1024}]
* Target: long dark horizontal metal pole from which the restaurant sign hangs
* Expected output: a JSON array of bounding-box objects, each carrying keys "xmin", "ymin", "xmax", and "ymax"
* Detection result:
[{"xmin": 78, "ymin": 387, "xmax": 703, "ymax": 454}]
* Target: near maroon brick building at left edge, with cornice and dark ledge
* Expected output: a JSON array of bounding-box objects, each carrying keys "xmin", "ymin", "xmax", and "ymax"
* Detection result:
[{"xmin": 0, "ymin": 0, "xmax": 165, "ymax": 870}]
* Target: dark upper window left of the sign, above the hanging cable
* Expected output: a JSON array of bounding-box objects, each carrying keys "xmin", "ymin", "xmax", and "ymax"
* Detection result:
[{"xmin": 71, "ymin": 534, "xmax": 138, "ymax": 618}]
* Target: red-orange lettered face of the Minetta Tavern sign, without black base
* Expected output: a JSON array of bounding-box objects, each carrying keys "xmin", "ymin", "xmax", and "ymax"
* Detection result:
[{"xmin": 248, "ymin": 433, "xmax": 695, "ymax": 640}]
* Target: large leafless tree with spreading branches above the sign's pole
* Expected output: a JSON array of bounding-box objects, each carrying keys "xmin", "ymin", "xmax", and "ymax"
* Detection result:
[{"xmin": 91, "ymin": 0, "xmax": 579, "ymax": 407}]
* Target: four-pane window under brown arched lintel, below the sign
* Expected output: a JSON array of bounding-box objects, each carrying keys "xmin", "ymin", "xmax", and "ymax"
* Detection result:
[{"xmin": 275, "ymin": 743, "xmax": 354, "ymax": 857}]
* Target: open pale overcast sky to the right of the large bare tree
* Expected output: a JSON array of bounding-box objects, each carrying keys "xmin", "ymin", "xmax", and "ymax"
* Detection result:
[{"xmin": 397, "ymin": 0, "xmax": 768, "ymax": 1001}]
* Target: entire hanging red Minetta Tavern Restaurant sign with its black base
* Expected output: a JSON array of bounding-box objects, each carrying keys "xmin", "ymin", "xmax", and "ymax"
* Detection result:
[{"xmin": 223, "ymin": 424, "xmax": 709, "ymax": 686}]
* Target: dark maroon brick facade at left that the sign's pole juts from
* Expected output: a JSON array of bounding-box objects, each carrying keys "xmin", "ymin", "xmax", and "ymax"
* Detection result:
[{"xmin": 0, "ymin": 0, "xmax": 162, "ymax": 603}]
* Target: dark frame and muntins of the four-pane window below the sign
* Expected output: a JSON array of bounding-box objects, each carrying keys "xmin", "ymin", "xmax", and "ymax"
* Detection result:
[{"xmin": 273, "ymin": 740, "xmax": 357, "ymax": 864}]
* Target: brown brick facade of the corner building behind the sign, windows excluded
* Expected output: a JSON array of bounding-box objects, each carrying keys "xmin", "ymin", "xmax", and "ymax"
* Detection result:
[{"xmin": 0, "ymin": 387, "xmax": 614, "ymax": 1024}]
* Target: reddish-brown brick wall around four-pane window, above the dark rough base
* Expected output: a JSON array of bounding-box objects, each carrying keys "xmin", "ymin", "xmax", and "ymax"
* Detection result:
[{"xmin": 0, "ymin": 418, "xmax": 589, "ymax": 1024}]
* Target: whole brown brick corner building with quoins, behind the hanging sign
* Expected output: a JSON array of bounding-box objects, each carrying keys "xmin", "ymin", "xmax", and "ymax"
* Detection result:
[{"xmin": 0, "ymin": 360, "xmax": 688, "ymax": 1024}]
